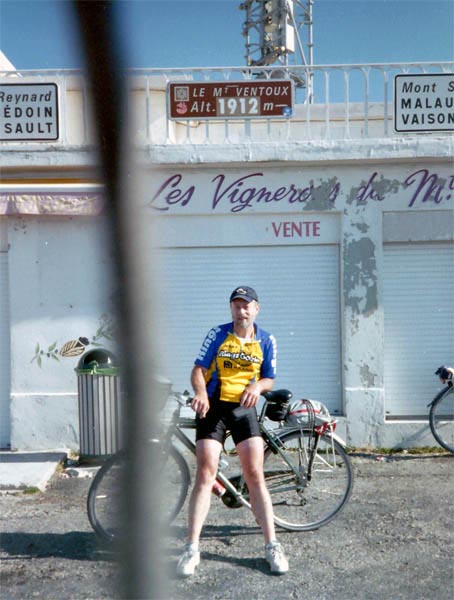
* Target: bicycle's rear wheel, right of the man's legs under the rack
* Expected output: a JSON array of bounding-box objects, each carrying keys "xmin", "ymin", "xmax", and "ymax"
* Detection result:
[{"xmin": 265, "ymin": 430, "xmax": 353, "ymax": 531}]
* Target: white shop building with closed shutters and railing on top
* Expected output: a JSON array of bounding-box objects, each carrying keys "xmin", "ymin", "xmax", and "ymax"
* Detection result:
[{"xmin": 0, "ymin": 64, "xmax": 454, "ymax": 449}]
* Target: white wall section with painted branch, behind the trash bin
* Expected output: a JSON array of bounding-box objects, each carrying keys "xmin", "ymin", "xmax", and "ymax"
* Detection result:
[{"xmin": 8, "ymin": 217, "xmax": 113, "ymax": 449}]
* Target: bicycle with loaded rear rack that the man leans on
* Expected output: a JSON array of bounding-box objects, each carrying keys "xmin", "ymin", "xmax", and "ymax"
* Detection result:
[{"xmin": 87, "ymin": 390, "xmax": 353, "ymax": 542}]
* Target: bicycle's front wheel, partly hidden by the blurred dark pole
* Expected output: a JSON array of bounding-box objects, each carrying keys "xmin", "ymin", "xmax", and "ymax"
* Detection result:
[{"xmin": 87, "ymin": 446, "xmax": 190, "ymax": 542}]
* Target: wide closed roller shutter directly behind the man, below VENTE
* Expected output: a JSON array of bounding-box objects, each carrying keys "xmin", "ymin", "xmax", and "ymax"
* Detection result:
[{"xmin": 153, "ymin": 245, "xmax": 341, "ymax": 413}]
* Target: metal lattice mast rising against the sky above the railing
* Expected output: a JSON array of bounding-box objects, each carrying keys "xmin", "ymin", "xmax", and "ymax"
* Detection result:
[{"xmin": 240, "ymin": 0, "xmax": 314, "ymax": 102}]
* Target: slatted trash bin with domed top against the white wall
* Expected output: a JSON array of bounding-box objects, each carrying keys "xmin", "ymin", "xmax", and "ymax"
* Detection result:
[{"xmin": 75, "ymin": 348, "xmax": 123, "ymax": 458}]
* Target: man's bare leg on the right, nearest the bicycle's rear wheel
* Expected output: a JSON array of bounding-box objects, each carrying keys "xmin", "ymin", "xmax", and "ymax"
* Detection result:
[{"xmin": 237, "ymin": 437, "xmax": 276, "ymax": 544}]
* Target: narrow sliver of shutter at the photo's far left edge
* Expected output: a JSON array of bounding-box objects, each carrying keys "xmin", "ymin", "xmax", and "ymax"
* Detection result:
[{"xmin": 0, "ymin": 251, "xmax": 10, "ymax": 448}]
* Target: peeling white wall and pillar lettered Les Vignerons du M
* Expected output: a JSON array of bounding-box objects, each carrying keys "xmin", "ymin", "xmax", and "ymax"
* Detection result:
[{"xmin": 144, "ymin": 156, "xmax": 454, "ymax": 447}]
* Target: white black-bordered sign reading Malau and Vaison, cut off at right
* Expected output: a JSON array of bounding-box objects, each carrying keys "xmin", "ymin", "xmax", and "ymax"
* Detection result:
[{"xmin": 394, "ymin": 73, "xmax": 454, "ymax": 133}]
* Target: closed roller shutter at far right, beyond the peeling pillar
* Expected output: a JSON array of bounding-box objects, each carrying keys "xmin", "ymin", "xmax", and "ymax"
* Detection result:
[{"xmin": 384, "ymin": 243, "xmax": 454, "ymax": 417}]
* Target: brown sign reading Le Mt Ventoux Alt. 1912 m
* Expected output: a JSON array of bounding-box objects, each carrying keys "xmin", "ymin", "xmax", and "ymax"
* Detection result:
[{"xmin": 167, "ymin": 79, "xmax": 294, "ymax": 121}]
